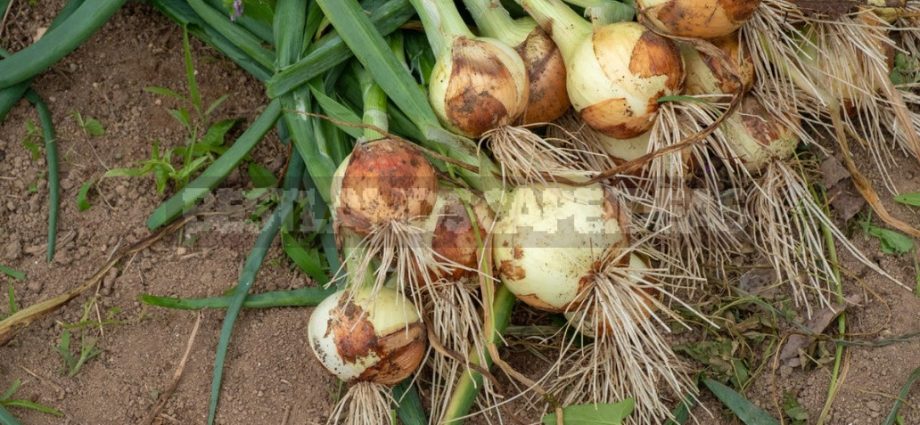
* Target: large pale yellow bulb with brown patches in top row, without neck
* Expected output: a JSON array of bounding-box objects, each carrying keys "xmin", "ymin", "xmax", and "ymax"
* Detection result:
[{"xmin": 566, "ymin": 22, "xmax": 684, "ymax": 139}]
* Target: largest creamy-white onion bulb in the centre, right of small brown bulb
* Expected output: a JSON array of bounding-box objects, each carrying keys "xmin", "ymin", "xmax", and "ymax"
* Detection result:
[{"xmin": 492, "ymin": 183, "xmax": 629, "ymax": 312}]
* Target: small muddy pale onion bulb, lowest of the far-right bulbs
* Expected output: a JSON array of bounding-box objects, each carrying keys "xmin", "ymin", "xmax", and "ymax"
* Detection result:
[{"xmin": 720, "ymin": 95, "xmax": 799, "ymax": 173}]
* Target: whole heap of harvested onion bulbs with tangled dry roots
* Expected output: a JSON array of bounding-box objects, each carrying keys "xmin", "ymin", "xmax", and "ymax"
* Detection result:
[{"xmin": 310, "ymin": 0, "xmax": 920, "ymax": 424}]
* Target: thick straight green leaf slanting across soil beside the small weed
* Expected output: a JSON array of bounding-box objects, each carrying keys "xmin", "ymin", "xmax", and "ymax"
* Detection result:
[{"xmin": 147, "ymin": 100, "xmax": 281, "ymax": 230}]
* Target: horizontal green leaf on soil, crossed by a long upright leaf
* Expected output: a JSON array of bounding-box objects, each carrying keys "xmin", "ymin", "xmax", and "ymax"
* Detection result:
[{"xmin": 140, "ymin": 287, "xmax": 336, "ymax": 310}]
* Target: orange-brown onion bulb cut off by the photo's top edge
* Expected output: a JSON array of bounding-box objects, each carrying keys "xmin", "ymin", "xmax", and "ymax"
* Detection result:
[{"xmin": 636, "ymin": 0, "xmax": 760, "ymax": 38}]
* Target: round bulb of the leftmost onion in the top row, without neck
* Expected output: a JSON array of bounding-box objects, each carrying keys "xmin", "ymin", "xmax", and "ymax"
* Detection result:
[{"xmin": 428, "ymin": 36, "xmax": 529, "ymax": 137}]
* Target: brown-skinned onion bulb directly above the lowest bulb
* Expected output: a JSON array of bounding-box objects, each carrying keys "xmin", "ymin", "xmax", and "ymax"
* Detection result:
[{"xmin": 332, "ymin": 139, "xmax": 438, "ymax": 235}]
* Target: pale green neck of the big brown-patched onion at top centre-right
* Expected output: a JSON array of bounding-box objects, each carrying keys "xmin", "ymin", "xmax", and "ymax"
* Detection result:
[{"xmin": 517, "ymin": 0, "xmax": 592, "ymax": 58}]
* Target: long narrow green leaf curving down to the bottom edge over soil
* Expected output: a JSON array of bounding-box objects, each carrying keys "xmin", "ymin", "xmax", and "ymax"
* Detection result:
[{"xmin": 208, "ymin": 151, "xmax": 304, "ymax": 425}]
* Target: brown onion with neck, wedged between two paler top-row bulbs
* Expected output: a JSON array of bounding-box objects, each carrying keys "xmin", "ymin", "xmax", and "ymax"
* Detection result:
[{"xmin": 464, "ymin": 0, "xmax": 571, "ymax": 124}]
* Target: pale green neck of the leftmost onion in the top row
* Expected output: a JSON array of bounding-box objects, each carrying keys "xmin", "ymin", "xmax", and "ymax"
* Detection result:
[{"xmin": 410, "ymin": 0, "xmax": 474, "ymax": 57}]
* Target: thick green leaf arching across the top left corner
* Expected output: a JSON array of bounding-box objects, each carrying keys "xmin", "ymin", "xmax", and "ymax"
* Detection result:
[{"xmin": 0, "ymin": 0, "xmax": 126, "ymax": 88}]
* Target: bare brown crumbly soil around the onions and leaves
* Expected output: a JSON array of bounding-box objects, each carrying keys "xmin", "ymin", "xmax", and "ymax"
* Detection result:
[{"xmin": 0, "ymin": 0, "xmax": 920, "ymax": 425}]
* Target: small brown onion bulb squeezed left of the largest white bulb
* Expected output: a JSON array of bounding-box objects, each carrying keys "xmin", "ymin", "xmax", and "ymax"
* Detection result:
[{"xmin": 419, "ymin": 189, "xmax": 494, "ymax": 283}]
